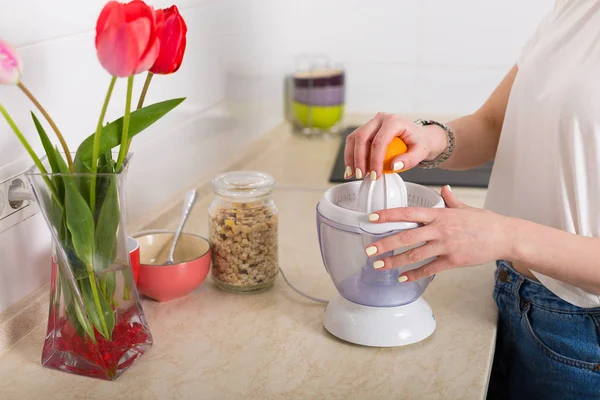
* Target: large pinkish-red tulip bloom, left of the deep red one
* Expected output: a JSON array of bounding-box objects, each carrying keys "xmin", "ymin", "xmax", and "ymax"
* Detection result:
[{"xmin": 96, "ymin": 0, "xmax": 162, "ymax": 77}]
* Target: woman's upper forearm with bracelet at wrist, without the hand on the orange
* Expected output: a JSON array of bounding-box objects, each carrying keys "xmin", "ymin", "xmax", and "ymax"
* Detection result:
[{"xmin": 424, "ymin": 66, "xmax": 518, "ymax": 170}]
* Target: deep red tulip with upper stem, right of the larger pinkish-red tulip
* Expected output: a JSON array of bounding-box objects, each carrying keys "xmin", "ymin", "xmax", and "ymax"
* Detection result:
[{"xmin": 137, "ymin": 5, "xmax": 187, "ymax": 110}]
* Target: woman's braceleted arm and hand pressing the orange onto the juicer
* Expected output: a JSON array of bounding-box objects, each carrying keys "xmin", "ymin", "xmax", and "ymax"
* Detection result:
[{"xmin": 344, "ymin": 66, "xmax": 517, "ymax": 179}]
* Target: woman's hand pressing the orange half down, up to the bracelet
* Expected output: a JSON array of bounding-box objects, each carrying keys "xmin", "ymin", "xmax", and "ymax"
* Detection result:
[{"xmin": 344, "ymin": 113, "xmax": 447, "ymax": 180}]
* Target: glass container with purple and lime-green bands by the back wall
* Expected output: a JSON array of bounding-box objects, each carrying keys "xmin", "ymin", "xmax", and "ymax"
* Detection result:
[{"xmin": 285, "ymin": 55, "xmax": 346, "ymax": 138}]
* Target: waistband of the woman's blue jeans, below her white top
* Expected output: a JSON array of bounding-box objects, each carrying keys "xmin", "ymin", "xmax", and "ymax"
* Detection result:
[{"xmin": 496, "ymin": 260, "xmax": 600, "ymax": 314}]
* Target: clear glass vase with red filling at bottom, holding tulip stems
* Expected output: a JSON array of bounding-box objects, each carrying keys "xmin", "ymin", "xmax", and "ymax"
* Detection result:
[{"xmin": 26, "ymin": 155, "xmax": 152, "ymax": 380}]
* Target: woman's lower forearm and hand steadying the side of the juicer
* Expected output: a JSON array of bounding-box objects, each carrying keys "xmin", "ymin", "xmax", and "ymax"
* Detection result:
[{"xmin": 365, "ymin": 187, "xmax": 600, "ymax": 295}]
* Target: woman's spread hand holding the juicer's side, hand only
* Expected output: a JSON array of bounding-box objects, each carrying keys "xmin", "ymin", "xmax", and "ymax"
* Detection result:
[{"xmin": 365, "ymin": 186, "xmax": 512, "ymax": 282}]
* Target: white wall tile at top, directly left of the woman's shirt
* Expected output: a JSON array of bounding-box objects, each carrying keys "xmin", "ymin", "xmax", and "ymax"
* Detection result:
[{"xmin": 422, "ymin": 0, "xmax": 554, "ymax": 69}]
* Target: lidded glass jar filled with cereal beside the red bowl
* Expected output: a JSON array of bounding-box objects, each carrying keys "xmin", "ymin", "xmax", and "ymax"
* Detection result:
[{"xmin": 208, "ymin": 171, "xmax": 279, "ymax": 292}]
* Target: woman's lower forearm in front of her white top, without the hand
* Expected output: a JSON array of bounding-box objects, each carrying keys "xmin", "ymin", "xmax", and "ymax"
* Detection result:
[{"xmin": 508, "ymin": 219, "xmax": 600, "ymax": 295}]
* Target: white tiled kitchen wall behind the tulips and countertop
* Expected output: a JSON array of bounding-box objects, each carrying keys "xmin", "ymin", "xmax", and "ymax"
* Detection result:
[{"xmin": 0, "ymin": 0, "xmax": 553, "ymax": 312}]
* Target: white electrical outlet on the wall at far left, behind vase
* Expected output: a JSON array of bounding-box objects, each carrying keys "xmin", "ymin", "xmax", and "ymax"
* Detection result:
[{"xmin": 0, "ymin": 175, "xmax": 37, "ymax": 233}]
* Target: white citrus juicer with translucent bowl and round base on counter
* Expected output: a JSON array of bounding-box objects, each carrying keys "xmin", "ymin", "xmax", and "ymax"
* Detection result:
[{"xmin": 317, "ymin": 173, "xmax": 445, "ymax": 347}]
